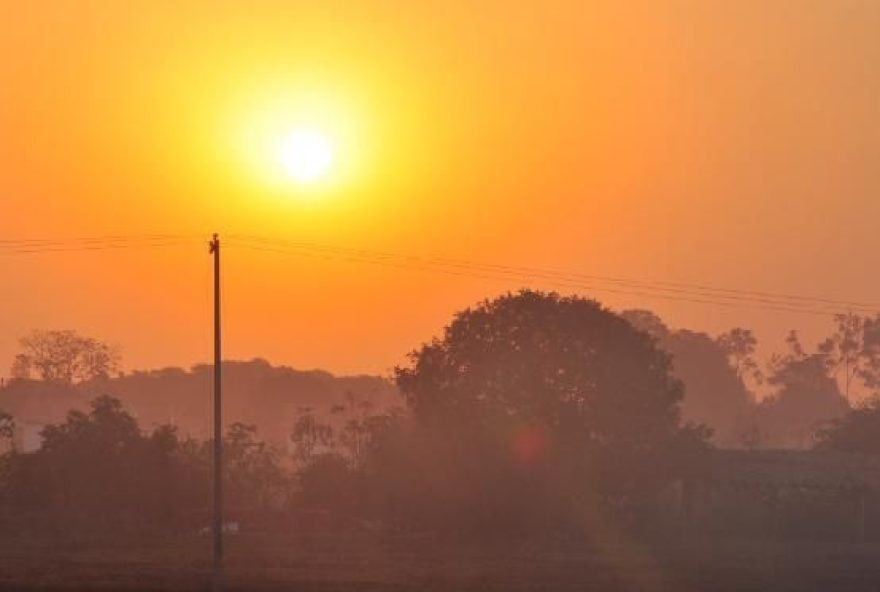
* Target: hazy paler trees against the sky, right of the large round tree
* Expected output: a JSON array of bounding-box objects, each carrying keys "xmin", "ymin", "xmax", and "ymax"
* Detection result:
[{"xmin": 622, "ymin": 310, "xmax": 868, "ymax": 449}]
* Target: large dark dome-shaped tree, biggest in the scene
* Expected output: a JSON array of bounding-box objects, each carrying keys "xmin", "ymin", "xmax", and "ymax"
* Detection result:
[{"xmin": 395, "ymin": 290, "xmax": 705, "ymax": 532}]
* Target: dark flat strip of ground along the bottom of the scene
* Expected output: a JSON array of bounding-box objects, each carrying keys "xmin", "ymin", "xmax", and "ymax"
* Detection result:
[{"xmin": 0, "ymin": 535, "xmax": 880, "ymax": 592}]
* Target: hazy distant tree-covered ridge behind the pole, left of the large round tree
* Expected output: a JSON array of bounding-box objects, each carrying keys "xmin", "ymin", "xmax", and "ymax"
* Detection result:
[{"xmin": 0, "ymin": 360, "xmax": 402, "ymax": 448}]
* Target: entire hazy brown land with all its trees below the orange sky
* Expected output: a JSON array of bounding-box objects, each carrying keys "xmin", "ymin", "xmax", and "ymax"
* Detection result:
[{"xmin": 0, "ymin": 290, "xmax": 880, "ymax": 590}]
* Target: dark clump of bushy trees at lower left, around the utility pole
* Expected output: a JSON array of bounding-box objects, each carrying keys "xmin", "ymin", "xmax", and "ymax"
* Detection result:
[{"xmin": 0, "ymin": 396, "xmax": 290, "ymax": 532}]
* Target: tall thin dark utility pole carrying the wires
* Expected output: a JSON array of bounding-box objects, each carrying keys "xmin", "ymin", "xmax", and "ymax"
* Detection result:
[{"xmin": 208, "ymin": 233, "xmax": 223, "ymax": 592}]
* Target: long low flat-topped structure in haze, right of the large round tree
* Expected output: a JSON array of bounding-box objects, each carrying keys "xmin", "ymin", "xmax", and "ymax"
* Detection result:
[{"xmin": 680, "ymin": 450, "xmax": 880, "ymax": 542}]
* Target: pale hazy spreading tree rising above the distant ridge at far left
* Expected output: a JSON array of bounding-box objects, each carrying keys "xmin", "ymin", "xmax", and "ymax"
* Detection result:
[{"xmin": 12, "ymin": 330, "xmax": 120, "ymax": 384}]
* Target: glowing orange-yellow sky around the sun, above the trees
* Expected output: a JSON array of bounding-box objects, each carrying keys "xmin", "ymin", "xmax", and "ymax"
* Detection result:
[{"xmin": 0, "ymin": 0, "xmax": 880, "ymax": 375}]
